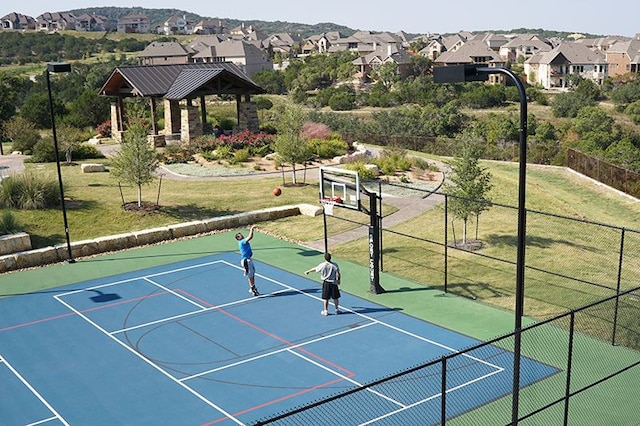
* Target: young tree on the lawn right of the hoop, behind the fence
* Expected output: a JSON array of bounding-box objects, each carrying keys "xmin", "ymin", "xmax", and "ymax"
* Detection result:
[{"xmin": 445, "ymin": 132, "xmax": 492, "ymax": 246}]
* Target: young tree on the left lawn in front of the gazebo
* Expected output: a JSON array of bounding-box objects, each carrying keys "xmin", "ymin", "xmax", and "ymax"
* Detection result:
[{"xmin": 111, "ymin": 119, "xmax": 158, "ymax": 207}]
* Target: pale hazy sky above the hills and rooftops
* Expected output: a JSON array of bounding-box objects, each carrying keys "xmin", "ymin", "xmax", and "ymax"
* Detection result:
[{"xmin": 6, "ymin": 0, "xmax": 640, "ymax": 37}]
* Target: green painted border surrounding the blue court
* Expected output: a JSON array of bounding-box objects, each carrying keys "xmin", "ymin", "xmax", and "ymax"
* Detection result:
[{"xmin": 0, "ymin": 230, "xmax": 640, "ymax": 425}]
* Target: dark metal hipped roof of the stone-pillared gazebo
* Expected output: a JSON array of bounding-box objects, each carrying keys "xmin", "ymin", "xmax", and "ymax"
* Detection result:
[{"xmin": 99, "ymin": 62, "xmax": 264, "ymax": 100}]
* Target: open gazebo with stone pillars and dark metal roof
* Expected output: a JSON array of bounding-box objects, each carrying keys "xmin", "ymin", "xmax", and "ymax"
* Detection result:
[{"xmin": 99, "ymin": 62, "xmax": 264, "ymax": 146}]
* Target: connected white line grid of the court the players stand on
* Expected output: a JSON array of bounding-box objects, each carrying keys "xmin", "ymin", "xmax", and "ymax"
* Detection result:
[{"xmin": 54, "ymin": 260, "xmax": 504, "ymax": 424}]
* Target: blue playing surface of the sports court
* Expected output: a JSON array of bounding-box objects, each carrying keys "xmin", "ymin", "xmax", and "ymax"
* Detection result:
[{"xmin": 0, "ymin": 253, "xmax": 556, "ymax": 426}]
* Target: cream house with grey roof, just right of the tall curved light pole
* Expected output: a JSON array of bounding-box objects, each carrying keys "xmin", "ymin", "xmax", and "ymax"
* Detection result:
[{"xmin": 524, "ymin": 42, "xmax": 609, "ymax": 89}]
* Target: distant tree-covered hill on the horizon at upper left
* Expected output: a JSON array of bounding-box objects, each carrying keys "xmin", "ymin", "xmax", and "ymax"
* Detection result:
[{"xmin": 68, "ymin": 7, "xmax": 355, "ymax": 37}]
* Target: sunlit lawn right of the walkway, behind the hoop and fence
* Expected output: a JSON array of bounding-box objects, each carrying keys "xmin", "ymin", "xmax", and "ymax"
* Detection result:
[{"xmin": 258, "ymin": 158, "xmax": 640, "ymax": 329}]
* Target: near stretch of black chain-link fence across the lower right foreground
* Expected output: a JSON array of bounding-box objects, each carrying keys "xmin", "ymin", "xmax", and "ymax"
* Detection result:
[{"xmin": 257, "ymin": 287, "xmax": 640, "ymax": 426}]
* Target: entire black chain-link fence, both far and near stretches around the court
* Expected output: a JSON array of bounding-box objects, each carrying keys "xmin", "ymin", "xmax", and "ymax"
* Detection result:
[{"xmin": 259, "ymin": 187, "xmax": 640, "ymax": 425}]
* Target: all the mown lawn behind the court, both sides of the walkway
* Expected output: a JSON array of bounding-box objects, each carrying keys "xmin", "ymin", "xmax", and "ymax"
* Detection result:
[{"xmin": 5, "ymin": 154, "xmax": 640, "ymax": 330}]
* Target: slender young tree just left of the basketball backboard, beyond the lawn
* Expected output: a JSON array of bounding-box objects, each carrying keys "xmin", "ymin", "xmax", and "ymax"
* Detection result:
[{"xmin": 274, "ymin": 104, "xmax": 310, "ymax": 184}]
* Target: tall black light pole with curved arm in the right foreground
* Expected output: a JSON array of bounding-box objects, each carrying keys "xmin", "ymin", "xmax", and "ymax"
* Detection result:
[{"xmin": 433, "ymin": 65, "xmax": 527, "ymax": 425}]
